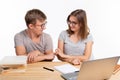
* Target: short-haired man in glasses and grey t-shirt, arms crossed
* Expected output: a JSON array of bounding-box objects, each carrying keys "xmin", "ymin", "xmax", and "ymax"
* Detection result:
[{"xmin": 14, "ymin": 9, "xmax": 54, "ymax": 63}]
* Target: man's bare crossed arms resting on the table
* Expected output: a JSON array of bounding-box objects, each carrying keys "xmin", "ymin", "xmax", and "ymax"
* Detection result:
[{"xmin": 15, "ymin": 46, "xmax": 54, "ymax": 63}]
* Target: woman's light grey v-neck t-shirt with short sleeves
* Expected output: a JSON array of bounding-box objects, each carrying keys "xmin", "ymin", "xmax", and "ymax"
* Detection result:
[{"xmin": 59, "ymin": 31, "xmax": 93, "ymax": 59}]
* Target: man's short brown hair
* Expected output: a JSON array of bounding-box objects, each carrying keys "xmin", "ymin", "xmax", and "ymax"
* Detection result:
[{"xmin": 25, "ymin": 9, "xmax": 47, "ymax": 26}]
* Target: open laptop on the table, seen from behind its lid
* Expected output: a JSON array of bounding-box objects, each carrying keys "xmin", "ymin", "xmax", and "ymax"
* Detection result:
[{"xmin": 61, "ymin": 56, "xmax": 120, "ymax": 80}]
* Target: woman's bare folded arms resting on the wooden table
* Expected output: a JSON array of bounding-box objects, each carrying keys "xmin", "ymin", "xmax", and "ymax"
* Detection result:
[{"xmin": 56, "ymin": 40, "xmax": 93, "ymax": 64}]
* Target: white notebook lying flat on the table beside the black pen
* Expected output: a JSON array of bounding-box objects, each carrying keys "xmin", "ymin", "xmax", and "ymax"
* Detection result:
[{"xmin": 54, "ymin": 64, "xmax": 79, "ymax": 74}]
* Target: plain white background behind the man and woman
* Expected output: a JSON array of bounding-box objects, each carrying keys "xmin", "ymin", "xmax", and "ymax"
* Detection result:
[{"xmin": 0, "ymin": 0, "xmax": 120, "ymax": 59}]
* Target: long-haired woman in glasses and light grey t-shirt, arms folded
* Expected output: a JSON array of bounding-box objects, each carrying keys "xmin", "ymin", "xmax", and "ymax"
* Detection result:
[{"xmin": 55, "ymin": 9, "xmax": 93, "ymax": 65}]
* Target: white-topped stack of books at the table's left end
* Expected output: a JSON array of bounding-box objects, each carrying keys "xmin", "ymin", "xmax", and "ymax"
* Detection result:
[{"xmin": 0, "ymin": 56, "xmax": 27, "ymax": 72}]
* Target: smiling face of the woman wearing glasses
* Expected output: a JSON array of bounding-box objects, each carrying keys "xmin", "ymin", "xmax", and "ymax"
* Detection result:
[{"xmin": 68, "ymin": 16, "xmax": 80, "ymax": 32}]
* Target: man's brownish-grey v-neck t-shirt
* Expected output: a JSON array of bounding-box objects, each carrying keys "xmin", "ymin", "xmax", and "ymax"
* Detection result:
[{"xmin": 14, "ymin": 30, "xmax": 53, "ymax": 53}]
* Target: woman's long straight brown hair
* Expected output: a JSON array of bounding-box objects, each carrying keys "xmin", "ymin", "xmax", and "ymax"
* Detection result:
[{"xmin": 67, "ymin": 9, "xmax": 90, "ymax": 40}]
